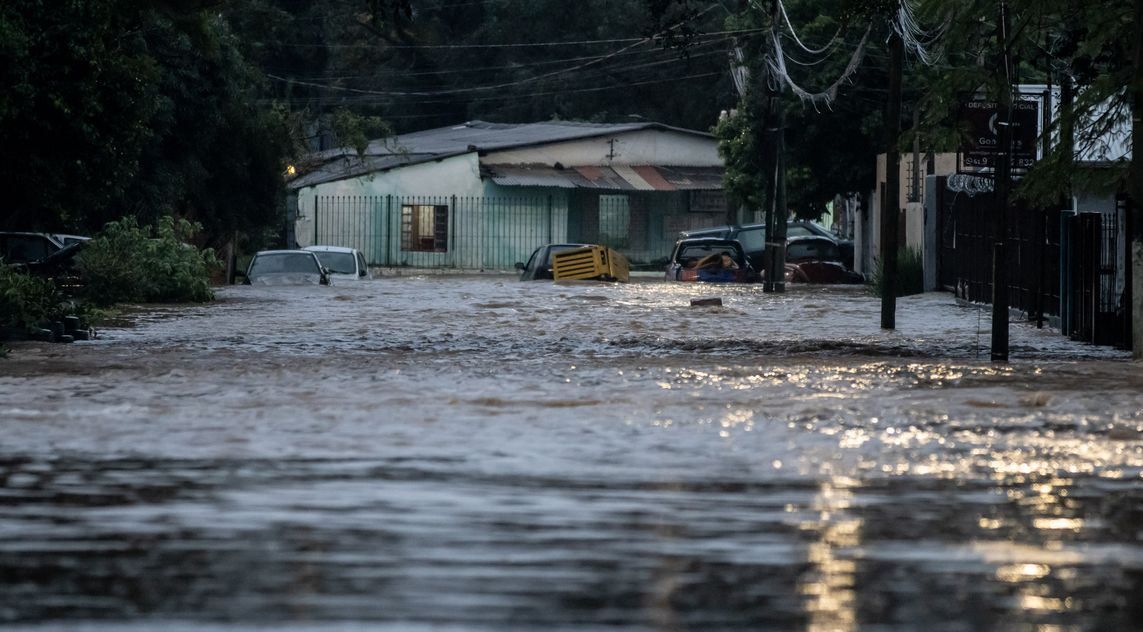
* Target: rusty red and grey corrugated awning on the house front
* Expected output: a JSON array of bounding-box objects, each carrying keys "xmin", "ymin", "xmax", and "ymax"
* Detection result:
[{"xmin": 480, "ymin": 165, "xmax": 722, "ymax": 191}]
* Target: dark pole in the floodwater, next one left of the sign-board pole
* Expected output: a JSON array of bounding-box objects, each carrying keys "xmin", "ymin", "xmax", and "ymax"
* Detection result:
[{"xmin": 881, "ymin": 31, "xmax": 904, "ymax": 329}]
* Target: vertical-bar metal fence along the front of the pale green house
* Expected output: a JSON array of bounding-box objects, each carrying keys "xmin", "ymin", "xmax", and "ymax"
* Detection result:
[{"xmin": 296, "ymin": 192, "xmax": 699, "ymax": 270}]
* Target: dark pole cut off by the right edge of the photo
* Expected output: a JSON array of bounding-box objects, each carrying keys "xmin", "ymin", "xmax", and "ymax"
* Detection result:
[{"xmin": 1127, "ymin": 0, "xmax": 1143, "ymax": 360}]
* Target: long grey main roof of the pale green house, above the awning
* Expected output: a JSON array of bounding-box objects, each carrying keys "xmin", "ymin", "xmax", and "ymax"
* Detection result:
[{"xmin": 287, "ymin": 121, "xmax": 712, "ymax": 190}]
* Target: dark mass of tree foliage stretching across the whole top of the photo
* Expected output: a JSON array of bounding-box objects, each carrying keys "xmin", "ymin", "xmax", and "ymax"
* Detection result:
[{"xmin": 0, "ymin": 0, "xmax": 1138, "ymax": 239}]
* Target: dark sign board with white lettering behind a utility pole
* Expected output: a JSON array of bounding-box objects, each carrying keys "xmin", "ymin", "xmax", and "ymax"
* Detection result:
[{"xmin": 958, "ymin": 98, "xmax": 1040, "ymax": 174}]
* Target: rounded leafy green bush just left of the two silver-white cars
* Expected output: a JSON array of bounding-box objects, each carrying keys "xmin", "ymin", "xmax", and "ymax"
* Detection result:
[{"xmin": 75, "ymin": 217, "xmax": 221, "ymax": 305}]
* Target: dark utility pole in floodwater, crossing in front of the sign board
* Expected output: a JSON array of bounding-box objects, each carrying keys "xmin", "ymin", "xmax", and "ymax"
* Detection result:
[{"xmin": 991, "ymin": 0, "xmax": 1012, "ymax": 362}]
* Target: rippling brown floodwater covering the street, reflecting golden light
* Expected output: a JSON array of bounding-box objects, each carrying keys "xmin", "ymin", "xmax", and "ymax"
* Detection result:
[{"xmin": 0, "ymin": 275, "xmax": 1143, "ymax": 632}]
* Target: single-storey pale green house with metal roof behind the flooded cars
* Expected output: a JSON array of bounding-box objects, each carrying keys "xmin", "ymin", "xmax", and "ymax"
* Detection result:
[{"xmin": 288, "ymin": 121, "xmax": 737, "ymax": 270}]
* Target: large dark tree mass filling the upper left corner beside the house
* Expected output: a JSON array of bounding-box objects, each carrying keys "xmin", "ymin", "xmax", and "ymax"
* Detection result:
[{"xmin": 0, "ymin": 0, "xmax": 288, "ymax": 241}]
